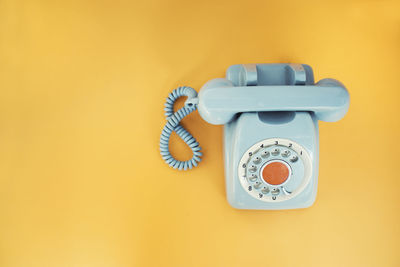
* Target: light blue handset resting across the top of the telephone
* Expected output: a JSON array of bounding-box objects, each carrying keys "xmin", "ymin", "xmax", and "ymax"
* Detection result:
[{"xmin": 198, "ymin": 79, "xmax": 349, "ymax": 124}]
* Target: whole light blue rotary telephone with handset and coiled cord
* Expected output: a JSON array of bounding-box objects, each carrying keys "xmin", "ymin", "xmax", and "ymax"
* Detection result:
[{"xmin": 160, "ymin": 64, "xmax": 349, "ymax": 210}]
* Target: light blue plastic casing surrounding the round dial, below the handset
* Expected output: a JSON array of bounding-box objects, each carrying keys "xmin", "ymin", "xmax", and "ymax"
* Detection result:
[{"xmin": 224, "ymin": 112, "xmax": 318, "ymax": 209}]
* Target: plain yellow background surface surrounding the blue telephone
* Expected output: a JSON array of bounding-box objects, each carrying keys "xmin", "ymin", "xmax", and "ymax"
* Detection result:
[{"xmin": 0, "ymin": 0, "xmax": 400, "ymax": 267}]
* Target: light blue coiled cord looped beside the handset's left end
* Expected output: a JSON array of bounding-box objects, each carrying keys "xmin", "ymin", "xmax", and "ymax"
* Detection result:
[{"xmin": 160, "ymin": 86, "xmax": 202, "ymax": 170}]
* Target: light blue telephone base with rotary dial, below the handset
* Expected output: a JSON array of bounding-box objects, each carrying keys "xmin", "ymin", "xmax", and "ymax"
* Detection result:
[{"xmin": 224, "ymin": 112, "xmax": 318, "ymax": 210}]
